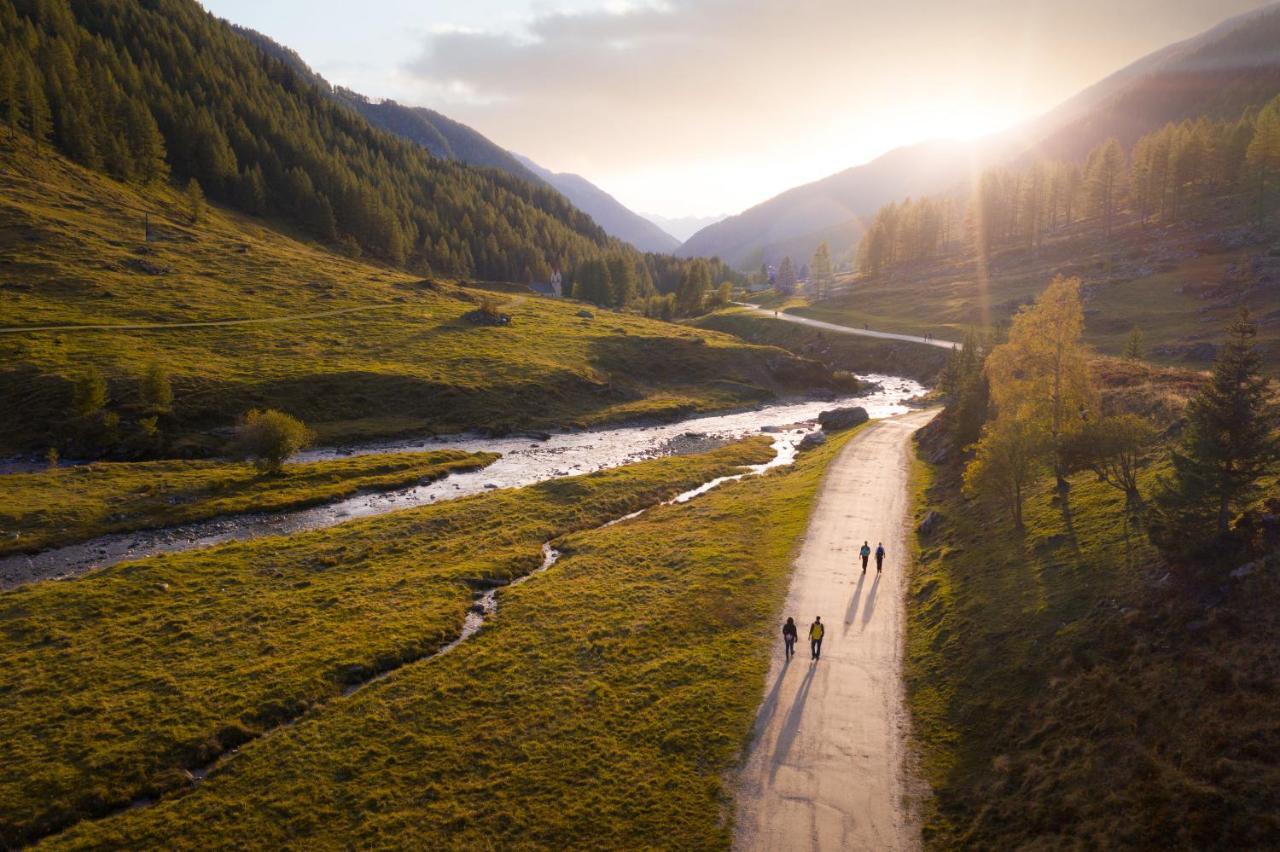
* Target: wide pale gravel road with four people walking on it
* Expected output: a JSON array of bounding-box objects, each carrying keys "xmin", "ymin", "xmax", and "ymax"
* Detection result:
[{"xmin": 733, "ymin": 411, "xmax": 936, "ymax": 852}]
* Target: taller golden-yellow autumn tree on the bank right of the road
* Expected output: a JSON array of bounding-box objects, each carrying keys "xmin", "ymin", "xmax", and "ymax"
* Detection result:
[{"xmin": 987, "ymin": 275, "xmax": 1097, "ymax": 487}]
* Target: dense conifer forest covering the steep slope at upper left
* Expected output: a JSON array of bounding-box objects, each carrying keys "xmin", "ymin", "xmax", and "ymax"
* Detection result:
[{"xmin": 0, "ymin": 0, "xmax": 614, "ymax": 280}]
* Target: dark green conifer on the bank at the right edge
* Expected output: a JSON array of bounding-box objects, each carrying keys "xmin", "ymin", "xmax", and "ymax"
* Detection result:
[{"xmin": 1152, "ymin": 310, "xmax": 1280, "ymax": 553}]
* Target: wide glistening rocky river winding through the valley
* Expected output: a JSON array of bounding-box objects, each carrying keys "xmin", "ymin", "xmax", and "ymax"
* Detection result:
[{"xmin": 0, "ymin": 375, "xmax": 924, "ymax": 590}]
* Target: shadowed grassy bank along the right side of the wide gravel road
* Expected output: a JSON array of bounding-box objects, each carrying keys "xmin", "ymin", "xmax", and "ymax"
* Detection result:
[{"xmin": 906, "ymin": 370, "xmax": 1280, "ymax": 849}]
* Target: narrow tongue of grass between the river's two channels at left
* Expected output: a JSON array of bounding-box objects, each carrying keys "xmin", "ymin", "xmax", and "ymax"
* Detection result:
[{"xmin": 0, "ymin": 450, "xmax": 498, "ymax": 554}]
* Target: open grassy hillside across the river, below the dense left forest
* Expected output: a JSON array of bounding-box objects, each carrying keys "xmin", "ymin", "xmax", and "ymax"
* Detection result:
[{"xmin": 0, "ymin": 138, "xmax": 824, "ymax": 454}]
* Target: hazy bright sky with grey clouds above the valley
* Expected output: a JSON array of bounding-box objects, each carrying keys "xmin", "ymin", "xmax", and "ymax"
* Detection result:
[{"xmin": 204, "ymin": 0, "xmax": 1267, "ymax": 215}]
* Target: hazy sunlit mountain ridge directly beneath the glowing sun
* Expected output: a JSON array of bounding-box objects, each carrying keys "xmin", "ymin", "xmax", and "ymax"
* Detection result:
[{"xmin": 678, "ymin": 4, "xmax": 1280, "ymax": 269}]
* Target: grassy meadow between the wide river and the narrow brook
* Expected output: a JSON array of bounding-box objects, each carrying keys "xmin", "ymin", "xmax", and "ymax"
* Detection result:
[{"xmin": 0, "ymin": 438, "xmax": 773, "ymax": 846}]
